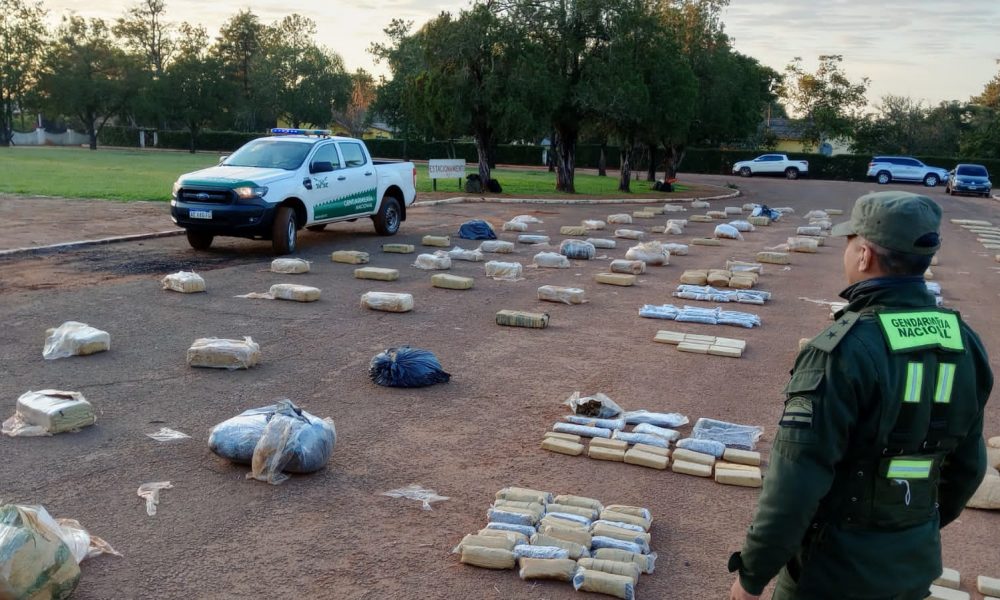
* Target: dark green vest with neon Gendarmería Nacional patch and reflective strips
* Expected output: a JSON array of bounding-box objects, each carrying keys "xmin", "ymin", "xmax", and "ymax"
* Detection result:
[{"xmin": 819, "ymin": 309, "xmax": 974, "ymax": 531}]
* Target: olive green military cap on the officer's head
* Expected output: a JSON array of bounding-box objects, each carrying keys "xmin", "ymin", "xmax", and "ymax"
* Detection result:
[{"xmin": 831, "ymin": 192, "xmax": 941, "ymax": 254}]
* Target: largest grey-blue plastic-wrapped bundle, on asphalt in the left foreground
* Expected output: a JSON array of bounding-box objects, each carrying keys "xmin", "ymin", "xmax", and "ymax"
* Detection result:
[{"xmin": 208, "ymin": 400, "xmax": 337, "ymax": 473}]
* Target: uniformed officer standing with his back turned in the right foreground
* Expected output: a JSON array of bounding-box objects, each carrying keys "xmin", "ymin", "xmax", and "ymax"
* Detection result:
[{"xmin": 729, "ymin": 192, "xmax": 993, "ymax": 600}]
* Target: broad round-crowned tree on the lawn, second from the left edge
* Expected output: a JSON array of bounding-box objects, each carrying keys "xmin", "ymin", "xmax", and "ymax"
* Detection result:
[{"xmin": 40, "ymin": 15, "xmax": 138, "ymax": 150}]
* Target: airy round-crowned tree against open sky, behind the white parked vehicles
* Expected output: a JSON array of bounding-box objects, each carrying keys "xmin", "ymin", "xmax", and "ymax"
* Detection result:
[{"xmin": 783, "ymin": 54, "xmax": 869, "ymax": 150}]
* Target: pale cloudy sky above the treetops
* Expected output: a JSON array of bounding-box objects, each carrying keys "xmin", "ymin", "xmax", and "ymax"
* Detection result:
[{"xmin": 42, "ymin": 0, "xmax": 1000, "ymax": 105}]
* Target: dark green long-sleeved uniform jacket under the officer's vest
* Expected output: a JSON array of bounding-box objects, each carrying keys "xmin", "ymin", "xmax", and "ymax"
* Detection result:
[{"xmin": 730, "ymin": 277, "xmax": 993, "ymax": 598}]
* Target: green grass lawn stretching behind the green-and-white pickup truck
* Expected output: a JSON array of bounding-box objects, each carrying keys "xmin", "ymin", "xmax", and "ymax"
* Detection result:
[{"xmin": 0, "ymin": 147, "xmax": 684, "ymax": 201}]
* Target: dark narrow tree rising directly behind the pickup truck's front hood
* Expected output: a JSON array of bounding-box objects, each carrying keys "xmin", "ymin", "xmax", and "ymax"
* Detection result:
[{"xmin": 164, "ymin": 23, "xmax": 232, "ymax": 154}]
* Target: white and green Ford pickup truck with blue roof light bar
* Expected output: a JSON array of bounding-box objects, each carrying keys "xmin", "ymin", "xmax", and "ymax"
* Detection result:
[{"xmin": 170, "ymin": 129, "xmax": 417, "ymax": 254}]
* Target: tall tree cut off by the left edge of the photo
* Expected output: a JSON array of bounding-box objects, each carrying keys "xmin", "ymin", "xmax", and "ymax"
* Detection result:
[{"xmin": 0, "ymin": 0, "xmax": 47, "ymax": 146}]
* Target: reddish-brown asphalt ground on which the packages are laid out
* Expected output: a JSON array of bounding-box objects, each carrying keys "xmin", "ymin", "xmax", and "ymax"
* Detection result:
[{"xmin": 0, "ymin": 177, "xmax": 1000, "ymax": 599}]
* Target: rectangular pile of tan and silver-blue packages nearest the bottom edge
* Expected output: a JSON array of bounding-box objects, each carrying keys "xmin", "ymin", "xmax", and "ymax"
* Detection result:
[{"xmin": 454, "ymin": 487, "xmax": 656, "ymax": 600}]
